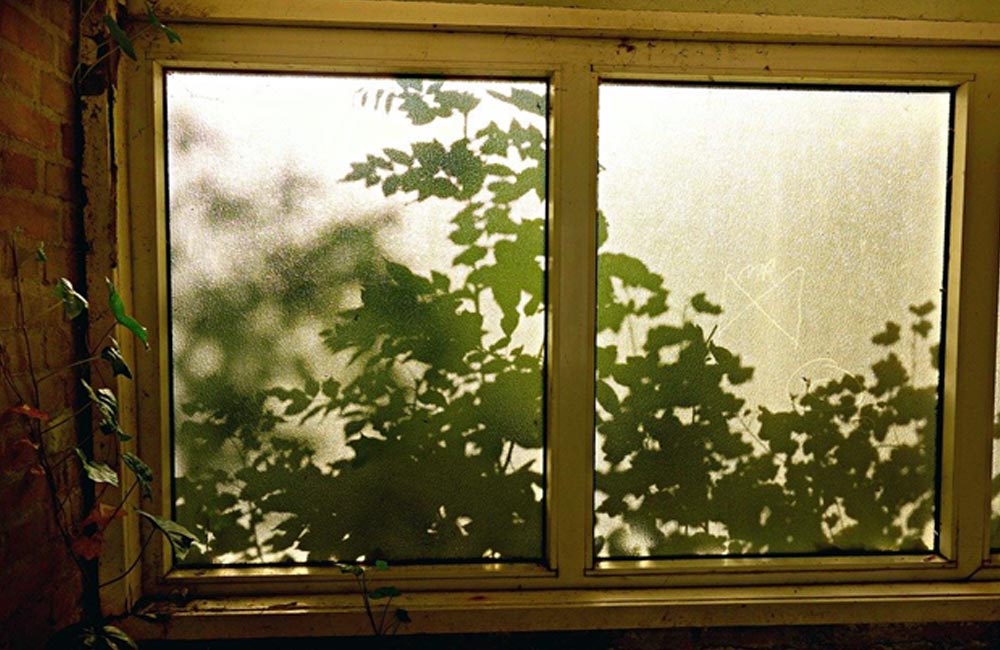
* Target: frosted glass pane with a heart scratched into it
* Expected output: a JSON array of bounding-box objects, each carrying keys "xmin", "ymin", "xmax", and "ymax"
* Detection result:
[{"xmin": 594, "ymin": 83, "xmax": 951, "ymax": 558}]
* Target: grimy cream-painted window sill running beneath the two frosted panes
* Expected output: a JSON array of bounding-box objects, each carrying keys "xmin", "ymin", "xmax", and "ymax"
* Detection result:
[{"xmin": 123, "ymin": 582, "xmax": 1000, "ymax": 640}]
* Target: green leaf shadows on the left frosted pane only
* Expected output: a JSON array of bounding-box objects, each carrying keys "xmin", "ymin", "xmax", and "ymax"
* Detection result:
[{"xmin": 174, "ymin": 79, "xmax": 545, "ymax": 562}]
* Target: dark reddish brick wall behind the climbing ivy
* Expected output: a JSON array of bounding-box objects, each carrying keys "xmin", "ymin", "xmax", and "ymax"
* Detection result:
[{"xmin": 0, "ymin": 0, "xmax": 83, "ymax": 649}]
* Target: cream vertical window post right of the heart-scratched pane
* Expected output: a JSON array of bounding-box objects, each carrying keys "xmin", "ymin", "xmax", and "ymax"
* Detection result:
[{"xmin": 941, "ymin": 78, "xmax": 998, "ymax": 574}]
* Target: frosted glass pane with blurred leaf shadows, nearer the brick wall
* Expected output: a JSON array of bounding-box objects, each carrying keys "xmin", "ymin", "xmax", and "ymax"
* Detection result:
[{"xmin": 167, "ymin": 72, "xmax": 547, "ymax": 564}]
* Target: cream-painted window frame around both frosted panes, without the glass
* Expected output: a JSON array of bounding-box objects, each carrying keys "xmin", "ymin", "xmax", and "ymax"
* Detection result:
[{"xmin": 113, "ymin": 0, "xmax": 1000, "ymax": 638}]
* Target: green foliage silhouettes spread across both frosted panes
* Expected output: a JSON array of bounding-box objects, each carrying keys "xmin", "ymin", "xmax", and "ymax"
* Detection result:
[{"xmin": 174, "ymin": 74, "xmax": 952, "ymax": 563}]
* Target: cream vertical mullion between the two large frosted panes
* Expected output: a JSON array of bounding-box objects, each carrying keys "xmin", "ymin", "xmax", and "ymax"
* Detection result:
[{"xmin": 548, "ymin": 64, "xmax": 597, "ymax": 585}]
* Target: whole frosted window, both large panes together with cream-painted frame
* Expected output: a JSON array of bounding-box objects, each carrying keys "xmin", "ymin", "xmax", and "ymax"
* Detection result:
[{"xmin": 117, "ymin": 3, "xmax": 1000, "ymax": 634}]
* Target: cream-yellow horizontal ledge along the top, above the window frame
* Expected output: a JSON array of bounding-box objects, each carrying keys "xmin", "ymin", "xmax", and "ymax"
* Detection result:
[{"xmin": 139, "ymin": 0, "xmax": 1000, "ymax": 46}]
